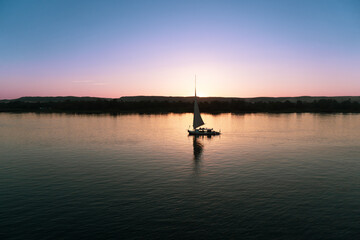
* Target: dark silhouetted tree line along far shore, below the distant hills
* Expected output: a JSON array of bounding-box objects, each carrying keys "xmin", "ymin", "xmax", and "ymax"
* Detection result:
[{"xmin": 0, "ymin": 99, "xmax": 360, "ymax": 113}]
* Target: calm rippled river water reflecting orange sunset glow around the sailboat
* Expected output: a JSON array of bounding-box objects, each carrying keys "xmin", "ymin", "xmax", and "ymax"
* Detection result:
[{"xmin": 0, "ymin": 113, "xmax": 360, "ymax": 239}]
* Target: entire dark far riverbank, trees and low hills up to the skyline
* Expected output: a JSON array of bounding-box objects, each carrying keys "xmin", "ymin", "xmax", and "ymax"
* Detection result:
[{"xmin": 0, "ymin": 97, "xmax": 360, "ymax": 113}]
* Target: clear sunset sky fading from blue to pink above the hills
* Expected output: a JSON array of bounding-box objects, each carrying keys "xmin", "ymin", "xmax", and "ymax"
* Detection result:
[{"xmin": 0, "ymin": 0, "xmax": 360, "ymax": 99}]
